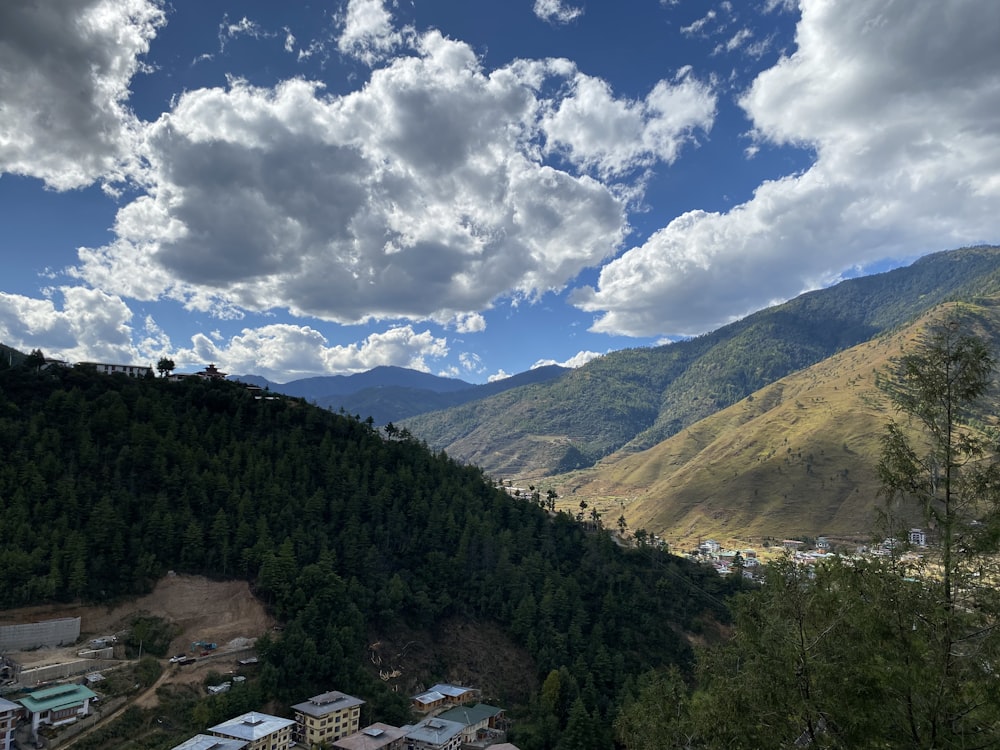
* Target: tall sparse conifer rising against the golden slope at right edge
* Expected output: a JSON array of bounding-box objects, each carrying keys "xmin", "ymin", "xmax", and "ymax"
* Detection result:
[{"xmin": 878, "ymin": 316, "xmax": 1000, "ymax": 747}]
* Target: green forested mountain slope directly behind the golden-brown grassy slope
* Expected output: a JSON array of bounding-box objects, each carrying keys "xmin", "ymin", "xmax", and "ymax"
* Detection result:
[{"xmin": 405, "ymin": 247, "xmax": 1000, "ymax": 476}]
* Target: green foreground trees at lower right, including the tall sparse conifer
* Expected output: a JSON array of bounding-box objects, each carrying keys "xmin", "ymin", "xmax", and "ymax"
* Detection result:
[{"xmin": 652, "ymin": 316, "xmax": 1000, "ymax": 750}]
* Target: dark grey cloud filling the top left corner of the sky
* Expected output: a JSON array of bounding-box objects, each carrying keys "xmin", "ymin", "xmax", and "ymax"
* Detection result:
[{"xmin": 0, "ymin": 0, "xmax": 164, "ymax": 190}]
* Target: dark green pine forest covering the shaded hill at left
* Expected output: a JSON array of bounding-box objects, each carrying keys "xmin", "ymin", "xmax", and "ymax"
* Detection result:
[{"xmin": 0, "ymin": 357, "xmax": 740, "ymax": 750}]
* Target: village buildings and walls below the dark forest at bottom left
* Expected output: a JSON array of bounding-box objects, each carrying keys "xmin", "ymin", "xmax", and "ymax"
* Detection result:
[{"xmin": 0, "ymin": 618, "xmax": 517, "ymax": 750}]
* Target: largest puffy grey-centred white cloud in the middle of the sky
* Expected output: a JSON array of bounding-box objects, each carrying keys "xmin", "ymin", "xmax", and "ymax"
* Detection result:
[{"xmin": 74, "ymin": 26, "xmax": 714, "ymax": 333}]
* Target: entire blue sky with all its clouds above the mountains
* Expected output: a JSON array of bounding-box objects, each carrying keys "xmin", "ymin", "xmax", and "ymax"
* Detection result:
[{"xmin": 0, "ymin": 0, "xmax": 1000, "ymax": 383}]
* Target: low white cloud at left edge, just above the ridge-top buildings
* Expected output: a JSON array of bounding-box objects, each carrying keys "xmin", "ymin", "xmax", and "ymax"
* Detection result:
[{"xmin": 0, "ymin": 287, "xmax": 139, "ymax": 362}]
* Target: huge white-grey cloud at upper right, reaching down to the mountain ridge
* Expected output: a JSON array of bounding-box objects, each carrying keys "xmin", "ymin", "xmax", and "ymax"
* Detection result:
[{"xmin": 574, "ymin": 0, "xmax": 1000, "ymax": 335}]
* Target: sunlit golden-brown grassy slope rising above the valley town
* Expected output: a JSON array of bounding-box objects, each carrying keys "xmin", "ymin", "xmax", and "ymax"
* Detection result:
[{"xmin": 553, "ymin": 299, "xmax": 1000, "ymax": 549}]
